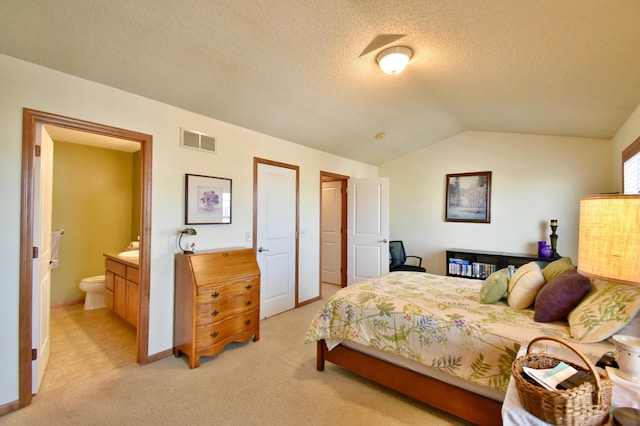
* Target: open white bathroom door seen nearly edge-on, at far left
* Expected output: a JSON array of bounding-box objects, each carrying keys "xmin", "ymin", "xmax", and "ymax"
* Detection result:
[{"xmin": 31, "ymin": 124, "xmax": 53, "ymax": 393}]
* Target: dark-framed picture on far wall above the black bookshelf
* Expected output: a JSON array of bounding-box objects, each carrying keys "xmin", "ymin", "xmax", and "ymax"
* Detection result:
[{"xmin": 445, "ymin": 172, "xmax": 491, "ymax": 223}]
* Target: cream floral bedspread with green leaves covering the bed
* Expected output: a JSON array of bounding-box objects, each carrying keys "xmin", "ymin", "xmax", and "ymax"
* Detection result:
[{"xmin": 305, "ymin": 272, "xmax": 569, "ymax": 392}]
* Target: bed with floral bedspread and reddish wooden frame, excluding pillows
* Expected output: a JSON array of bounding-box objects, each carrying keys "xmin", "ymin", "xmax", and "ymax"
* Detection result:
[{"xmin": 305, "ymin": 272, "xmax": 612, "ymax": 425}]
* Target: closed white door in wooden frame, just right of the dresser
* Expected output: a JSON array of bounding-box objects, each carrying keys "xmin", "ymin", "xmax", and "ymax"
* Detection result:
[{"xmin": 256, "ymin": 163, "xmax": 298, "ymax": 318}]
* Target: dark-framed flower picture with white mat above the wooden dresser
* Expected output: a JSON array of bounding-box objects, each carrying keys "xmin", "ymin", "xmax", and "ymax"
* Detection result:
[{"xmin": 184, "ymin": 173, "xmax": 231, "ymax": 225}]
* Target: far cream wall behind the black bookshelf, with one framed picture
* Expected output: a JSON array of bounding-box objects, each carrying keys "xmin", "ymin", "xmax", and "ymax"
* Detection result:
[{"xmin": 379, "ymin": 132, "xmax": 613, "ymax": 274}]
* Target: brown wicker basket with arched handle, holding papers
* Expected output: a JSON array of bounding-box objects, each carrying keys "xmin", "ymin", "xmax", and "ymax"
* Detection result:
[{"xmin": 511, "ymin": 336, "xmax": 613, "ymax": 425}]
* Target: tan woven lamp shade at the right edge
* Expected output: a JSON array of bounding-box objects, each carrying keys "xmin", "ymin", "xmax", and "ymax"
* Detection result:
[{"xmin": 578, "ymin": 195, "xmax": 640, "ymax": 285}]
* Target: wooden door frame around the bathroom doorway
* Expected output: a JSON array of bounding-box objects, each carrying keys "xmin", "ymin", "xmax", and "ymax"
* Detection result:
[{"xmin": 17, "ymin": 108, "xmax": 153, "ymax": 410}]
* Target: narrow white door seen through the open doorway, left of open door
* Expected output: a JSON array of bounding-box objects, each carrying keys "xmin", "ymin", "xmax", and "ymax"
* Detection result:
[{"xmin": 320, "ymin": 181, "xmax": 342, "ymax": 284}]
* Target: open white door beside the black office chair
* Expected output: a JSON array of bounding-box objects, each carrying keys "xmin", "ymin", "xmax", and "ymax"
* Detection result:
[{"xmin": 347, "ymin": 178, "xmax": 389, "ymax": 284}]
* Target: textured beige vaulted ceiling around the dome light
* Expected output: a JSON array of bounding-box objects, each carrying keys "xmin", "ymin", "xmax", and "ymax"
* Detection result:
[{"xmin": 0, "ymin": 0, "xmax": 640, "ymax": 165}]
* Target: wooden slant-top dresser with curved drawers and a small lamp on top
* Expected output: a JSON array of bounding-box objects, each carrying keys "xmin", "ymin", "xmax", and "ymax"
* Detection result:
[{"xmin": 173, "ymin": 248, "xmax": 260, "ymax": 368}]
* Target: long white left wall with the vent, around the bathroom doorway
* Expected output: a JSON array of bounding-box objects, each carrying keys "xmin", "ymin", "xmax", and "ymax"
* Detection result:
[{"xmin": 0, "ymin": 55, "xmax": 377, "ymax": 405}]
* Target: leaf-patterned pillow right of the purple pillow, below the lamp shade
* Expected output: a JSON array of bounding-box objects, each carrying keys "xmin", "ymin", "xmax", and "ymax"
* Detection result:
[{"xmin": 568, "ymin": 279, "xmax": 640, "ymax": 343}]
